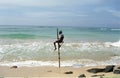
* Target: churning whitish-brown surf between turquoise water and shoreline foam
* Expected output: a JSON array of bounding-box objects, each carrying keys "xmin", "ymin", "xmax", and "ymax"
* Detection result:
[{"xmin": 0, "ymin": 40, "xmax": 120, "ymax": 62}]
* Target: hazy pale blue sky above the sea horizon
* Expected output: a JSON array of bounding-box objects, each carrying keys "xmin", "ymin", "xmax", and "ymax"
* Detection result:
[{"xmin": 0, "ymin": 0, "xmax": 120, "ymax": 27}]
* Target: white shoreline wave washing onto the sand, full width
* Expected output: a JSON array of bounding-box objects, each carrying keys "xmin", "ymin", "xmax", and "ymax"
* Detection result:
[{"xmin": 0, "ymin": 56, "xmax": 120, "ymax": 68}]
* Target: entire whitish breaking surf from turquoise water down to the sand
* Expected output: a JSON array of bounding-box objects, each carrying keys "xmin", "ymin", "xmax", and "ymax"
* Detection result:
[{"xmin": 0, "ymin": 40, "xmax": 120, "ymax": 66}]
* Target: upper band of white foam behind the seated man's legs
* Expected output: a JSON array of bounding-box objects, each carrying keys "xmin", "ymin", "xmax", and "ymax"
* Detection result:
[{"xmin": 0, "ymin": 41, "xmax": 120, "ymax": 53}]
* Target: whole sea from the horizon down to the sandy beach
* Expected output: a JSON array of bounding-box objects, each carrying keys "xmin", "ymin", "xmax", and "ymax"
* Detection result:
[{"xmin": 0, "ymin": 25, "xmax": 120, "ymax": 67}]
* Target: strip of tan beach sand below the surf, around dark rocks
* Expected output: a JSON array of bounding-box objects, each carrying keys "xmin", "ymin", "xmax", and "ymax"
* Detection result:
[{"xmin": 0, "ymin": 66, "xmax": 120, "ymax": 78}]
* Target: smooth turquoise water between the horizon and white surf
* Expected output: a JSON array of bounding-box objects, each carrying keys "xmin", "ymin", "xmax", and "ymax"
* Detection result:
[{"xmin": 0, "ymin": 25, "xmax": 120, "ymax": 42}]
